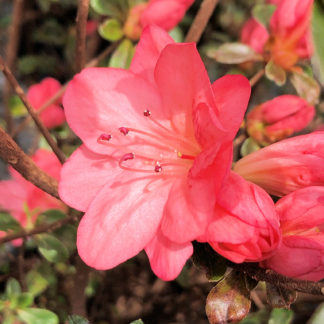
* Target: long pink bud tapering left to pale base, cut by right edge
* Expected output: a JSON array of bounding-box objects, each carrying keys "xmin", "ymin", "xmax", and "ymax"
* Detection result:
[{"xmin": 234, "ymin": 132, "xmax": 324, "ymax": 197}]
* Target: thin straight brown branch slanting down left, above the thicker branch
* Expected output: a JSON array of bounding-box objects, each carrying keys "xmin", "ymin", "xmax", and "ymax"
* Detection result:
[{"xmin": 0, "ymin": 56, "xmax": 66, "ymax": 163}]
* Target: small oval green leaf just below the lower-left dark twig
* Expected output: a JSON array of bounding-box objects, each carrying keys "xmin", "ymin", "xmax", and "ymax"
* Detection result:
[{"xmin": 35, "ymin": 234, "xmax": 69, "ymax": 263}]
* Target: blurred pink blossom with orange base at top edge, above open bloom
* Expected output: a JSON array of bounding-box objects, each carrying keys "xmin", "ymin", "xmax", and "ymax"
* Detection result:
[{"xmin": 124, "ymin": 0, "xmax": 194, "ymax": 40}]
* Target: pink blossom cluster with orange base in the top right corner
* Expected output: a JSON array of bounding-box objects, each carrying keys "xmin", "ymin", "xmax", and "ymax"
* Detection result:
[{"xmin": 241, "ymin": 0, "xmax": 313, "ymax": 70}]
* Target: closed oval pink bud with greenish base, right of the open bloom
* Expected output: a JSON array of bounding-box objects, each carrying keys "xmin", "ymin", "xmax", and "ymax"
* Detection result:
[{"xmin": 246, "ymin": 95, "xmax": 315, "ymax": 145}]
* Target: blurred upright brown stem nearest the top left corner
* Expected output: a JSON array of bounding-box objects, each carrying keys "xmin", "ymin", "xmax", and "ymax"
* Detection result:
[{"xmin": 3, "ymin": 0, "xmax": 24, "ymax": 132}]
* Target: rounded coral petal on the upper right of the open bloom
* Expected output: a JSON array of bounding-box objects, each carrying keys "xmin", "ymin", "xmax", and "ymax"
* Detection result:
[{"xmin": 212, "ymin": 75, "xmax": 251, "ymax": 140}]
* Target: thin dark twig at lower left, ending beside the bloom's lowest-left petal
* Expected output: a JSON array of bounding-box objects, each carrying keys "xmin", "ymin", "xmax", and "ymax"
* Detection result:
[{"xmin": 0, "ymin": 215, "xmax": 79, "ymax": 244}]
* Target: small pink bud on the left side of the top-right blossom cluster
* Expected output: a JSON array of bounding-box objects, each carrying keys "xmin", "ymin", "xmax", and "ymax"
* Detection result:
[{"xmin": 241, "ymin": 18, "xmax": 269, "ymax": 54}]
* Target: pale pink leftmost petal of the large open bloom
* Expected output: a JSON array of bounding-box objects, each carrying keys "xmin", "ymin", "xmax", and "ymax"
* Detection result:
[{"xmin": 59, "ymin": 145, "xmax": 122, "ymax": 211}]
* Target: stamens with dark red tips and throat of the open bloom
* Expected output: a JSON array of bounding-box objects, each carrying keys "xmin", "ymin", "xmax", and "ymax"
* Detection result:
[{"xmin": 97, "ymin": 110, "xmax": 200, "ymax": 175}]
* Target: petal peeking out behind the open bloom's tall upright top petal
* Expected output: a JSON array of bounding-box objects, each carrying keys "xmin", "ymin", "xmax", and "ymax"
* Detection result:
[{"xmin": 130, "ymin": 26, "xmax": 174, "ymax": 83}]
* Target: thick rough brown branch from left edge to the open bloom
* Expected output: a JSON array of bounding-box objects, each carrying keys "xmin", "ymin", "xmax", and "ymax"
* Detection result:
[{"xmin": 0, "ymin": 128, "xmax": 60, "ymax": 199}]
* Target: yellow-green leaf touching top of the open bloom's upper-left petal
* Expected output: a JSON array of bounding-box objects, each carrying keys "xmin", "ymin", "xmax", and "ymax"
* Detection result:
[{"xmin": 109, "ymin": 39, "xmax": 135, "ymax": 69}]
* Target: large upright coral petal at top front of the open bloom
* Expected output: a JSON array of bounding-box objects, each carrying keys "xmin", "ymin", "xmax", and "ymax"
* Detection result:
[{"xmin": 155, "ymin": 43, "xmax": 221, "ymax": 146}]
